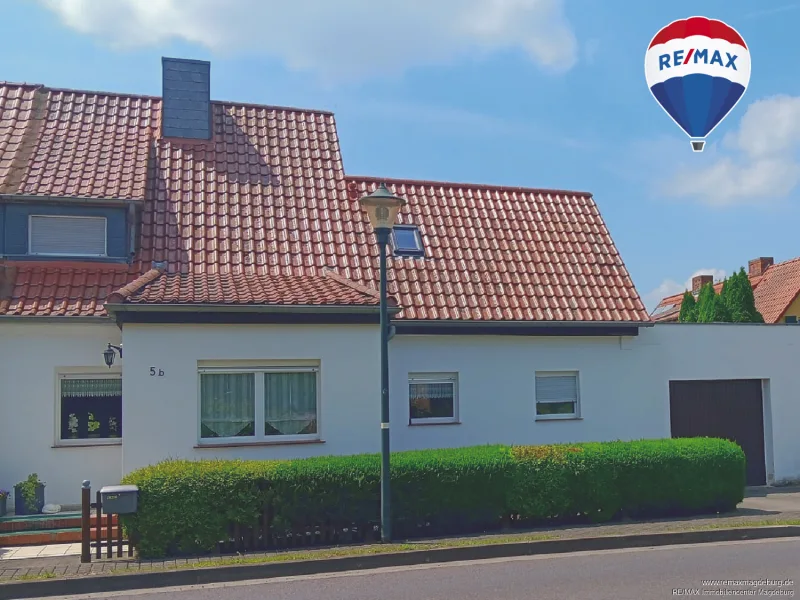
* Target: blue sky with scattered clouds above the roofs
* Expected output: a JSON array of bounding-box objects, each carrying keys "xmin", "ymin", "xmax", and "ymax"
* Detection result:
[{"xmin": 0, "ymin": 0, "xmax": 800, "ymax": 308}]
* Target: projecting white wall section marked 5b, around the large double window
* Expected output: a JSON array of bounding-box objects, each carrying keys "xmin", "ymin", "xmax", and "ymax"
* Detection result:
[{"xmin": 122, "ymin": 324, "xmax": 380, "ymax": 473}]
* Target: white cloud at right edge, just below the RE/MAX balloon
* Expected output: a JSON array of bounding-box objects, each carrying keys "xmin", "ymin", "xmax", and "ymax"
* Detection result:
[{"xmin": 662, "ymin": 95, "xmax": 800, "ymax": 206}]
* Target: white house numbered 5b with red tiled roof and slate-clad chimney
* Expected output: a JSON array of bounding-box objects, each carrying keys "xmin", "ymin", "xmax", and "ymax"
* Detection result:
[{"xmin": 0, "ymin": 59, "xmax": 800, "ymax": 506}]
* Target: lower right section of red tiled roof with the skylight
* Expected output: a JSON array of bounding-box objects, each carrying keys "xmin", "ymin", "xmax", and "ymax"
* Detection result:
[{"xmin": 342, "ymin": 177, "xmax": 647, "ymax": 321}]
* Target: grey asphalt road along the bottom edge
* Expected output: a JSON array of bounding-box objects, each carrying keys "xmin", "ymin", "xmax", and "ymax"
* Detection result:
[{"xmin": 53, "ymin": 538, "xmax": 800, "ymax": 600}]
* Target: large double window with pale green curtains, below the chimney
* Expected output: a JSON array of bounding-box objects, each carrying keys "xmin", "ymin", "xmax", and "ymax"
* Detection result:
[{"xmin": 200, "ymin": 367, "xmax": 319, "ymax": 443}]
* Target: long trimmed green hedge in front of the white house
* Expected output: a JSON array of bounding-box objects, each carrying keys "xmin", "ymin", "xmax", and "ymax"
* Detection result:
[{"xmin": 123, "ymin": 438, "xmax": 745, "ymax": 557}]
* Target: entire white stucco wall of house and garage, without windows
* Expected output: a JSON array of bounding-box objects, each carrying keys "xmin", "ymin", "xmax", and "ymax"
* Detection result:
[{"xmin": 7, "ymin": 322, "xmax": 800, "ymax": 504}]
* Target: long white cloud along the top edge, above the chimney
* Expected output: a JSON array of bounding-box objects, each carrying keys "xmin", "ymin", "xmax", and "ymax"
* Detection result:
[{"xmin": 38, "ymin": 0, "xmax": 578, "ymax": 78}]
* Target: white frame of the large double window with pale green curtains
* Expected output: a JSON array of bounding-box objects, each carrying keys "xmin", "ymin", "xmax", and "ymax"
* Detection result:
[{"xmin": 197, "ymin": 366, "xmax": 322, "ymax": 446}]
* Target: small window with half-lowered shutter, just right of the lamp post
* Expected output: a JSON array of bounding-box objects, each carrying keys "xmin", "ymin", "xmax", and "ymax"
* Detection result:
[{"xmin": 408, "ymin": 373, "xmax": 458, "ymax": 425}]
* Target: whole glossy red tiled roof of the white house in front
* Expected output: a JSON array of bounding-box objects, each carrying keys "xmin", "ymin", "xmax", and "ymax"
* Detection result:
[{"xmin": 0, "ymin": 79, "xmax": 649, "ymax": 322}]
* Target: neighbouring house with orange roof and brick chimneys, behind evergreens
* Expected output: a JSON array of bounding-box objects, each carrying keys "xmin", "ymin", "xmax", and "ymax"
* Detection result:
[{"xmin": 650, "ymin": 256, "xmax": 800, "ymax": 323}]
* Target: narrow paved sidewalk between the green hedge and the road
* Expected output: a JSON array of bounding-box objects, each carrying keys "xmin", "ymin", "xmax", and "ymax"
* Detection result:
[{"xmin": 0, "ymin": 488, "xmax": 800, "ymax": 582}]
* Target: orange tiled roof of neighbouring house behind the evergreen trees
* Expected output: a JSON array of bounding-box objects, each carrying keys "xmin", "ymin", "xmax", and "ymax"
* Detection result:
[{"xmin": 651, "ymin": 258, "xmax": 800, "ymax": 323}]
